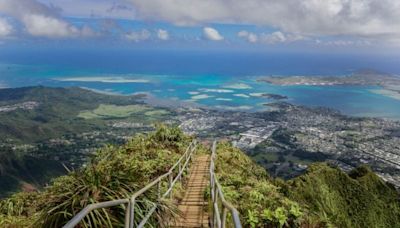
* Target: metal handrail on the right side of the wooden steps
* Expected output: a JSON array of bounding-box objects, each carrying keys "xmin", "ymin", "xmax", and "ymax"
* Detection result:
[{"xmin": 210, "ymin": 141, "xmax": 242, "ymax": 228}]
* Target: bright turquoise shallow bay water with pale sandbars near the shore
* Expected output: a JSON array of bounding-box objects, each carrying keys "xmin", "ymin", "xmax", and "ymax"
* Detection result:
[{"xmin": 0, "ymin": 64, "xmax": 400, "ymax": 119}]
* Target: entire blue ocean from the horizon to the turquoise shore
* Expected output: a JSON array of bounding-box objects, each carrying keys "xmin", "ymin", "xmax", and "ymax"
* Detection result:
[{"xmin": 0, "ymin": 50, "xmax": 400, "ymax": 119}]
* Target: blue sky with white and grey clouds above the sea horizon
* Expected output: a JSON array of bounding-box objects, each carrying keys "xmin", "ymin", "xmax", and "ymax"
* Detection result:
[{"xmin": 0, "ymin": 0, "xmax": 400, "ymax": 54}]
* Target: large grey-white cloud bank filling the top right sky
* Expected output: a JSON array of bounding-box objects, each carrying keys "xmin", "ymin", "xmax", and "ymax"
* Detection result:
[{"xmin": 129, "ymin": 0, "xmax": 400, "ymax": 40}]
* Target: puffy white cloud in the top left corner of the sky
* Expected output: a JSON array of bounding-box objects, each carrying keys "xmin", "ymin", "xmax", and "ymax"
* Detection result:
[{"xmin": 0, "ymin": 0, "xmax": 94, "ymax": 38}]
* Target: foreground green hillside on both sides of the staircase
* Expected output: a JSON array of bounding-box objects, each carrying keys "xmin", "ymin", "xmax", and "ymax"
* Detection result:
[{"xmin": 0, "ymin": 129, "xmax": 400, "ymax": 228}]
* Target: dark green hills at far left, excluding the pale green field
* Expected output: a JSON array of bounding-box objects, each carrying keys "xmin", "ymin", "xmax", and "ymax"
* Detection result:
[{"xmin": 0, "ymin": 87, "xmax": 139, "ymax": 143}]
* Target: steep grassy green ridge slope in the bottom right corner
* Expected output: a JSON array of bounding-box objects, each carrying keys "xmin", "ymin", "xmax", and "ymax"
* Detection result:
[{"xmin": 286, "ymin": 163, "xmax": 400, "ymax": 227}]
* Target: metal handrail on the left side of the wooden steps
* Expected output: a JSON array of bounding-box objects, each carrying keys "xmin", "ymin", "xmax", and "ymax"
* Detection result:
[{"xmin": 63, "ymin": 140, "xmax": 197, "ymax": 228}]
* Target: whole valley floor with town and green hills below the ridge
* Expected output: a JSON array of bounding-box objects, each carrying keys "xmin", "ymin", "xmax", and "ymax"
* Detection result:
[{"xmin": 0, "ymin": 87, "xmax": 400, "ymax": 196}]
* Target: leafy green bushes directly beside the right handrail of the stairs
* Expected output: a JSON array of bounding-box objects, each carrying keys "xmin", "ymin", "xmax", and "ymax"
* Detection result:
[{"xmin": 216, "ymin": 142, "xmax": 303, "ymax": 227}]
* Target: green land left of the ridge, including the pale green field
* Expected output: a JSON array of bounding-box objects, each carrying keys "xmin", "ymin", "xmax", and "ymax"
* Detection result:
[{"xmin": 0, "ymin": 87, "xmax": 175, "ymax": 198}]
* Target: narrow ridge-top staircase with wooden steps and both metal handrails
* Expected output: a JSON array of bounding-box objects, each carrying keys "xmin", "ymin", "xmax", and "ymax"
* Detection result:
[{"xmin": 64, "ymin": 140, "xmax": 242, "ymax": 228}]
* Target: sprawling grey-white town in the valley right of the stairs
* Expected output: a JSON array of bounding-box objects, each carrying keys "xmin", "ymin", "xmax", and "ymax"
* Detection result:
[{"xmin": 179, "ymin": 103, "xmax": 400, "ymax": 187}]
